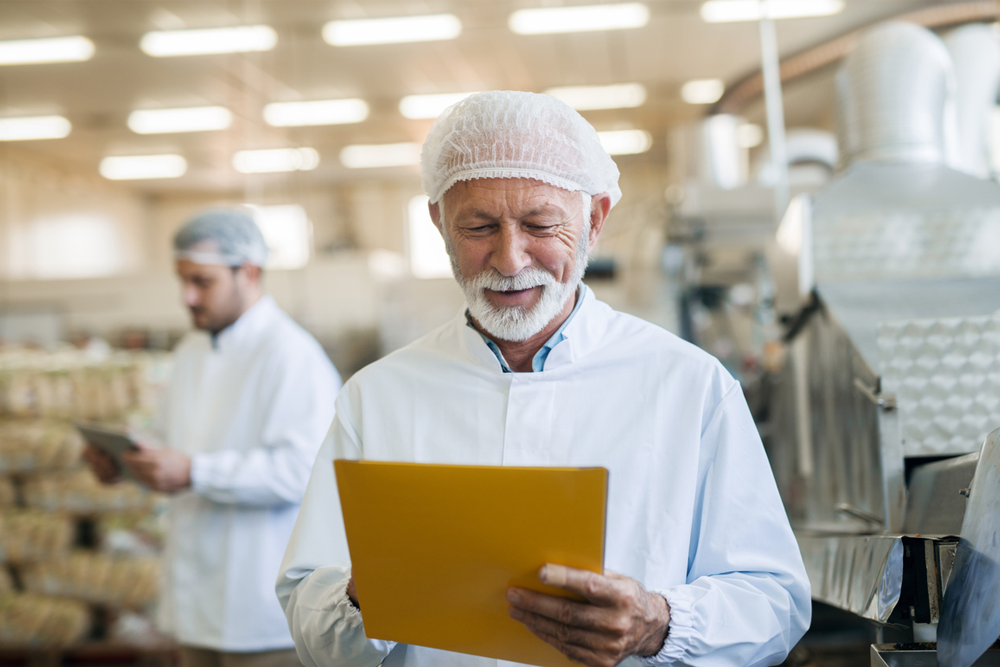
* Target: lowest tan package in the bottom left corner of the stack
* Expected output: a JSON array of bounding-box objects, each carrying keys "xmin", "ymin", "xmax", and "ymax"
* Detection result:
[{"xmin": 0, "ymin": 593, "xmax": 90, "ymax": 648}]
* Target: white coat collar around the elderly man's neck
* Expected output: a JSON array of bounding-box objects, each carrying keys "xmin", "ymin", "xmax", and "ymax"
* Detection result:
[{"xmin": 453, "ymin": 283, "xmax": 612, "ymax": 375}]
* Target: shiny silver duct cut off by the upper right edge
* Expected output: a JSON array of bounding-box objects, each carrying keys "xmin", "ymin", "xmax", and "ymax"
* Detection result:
[{"xmin": 944, "ymin": 24, "xmax": 1000, "ymax": 178}]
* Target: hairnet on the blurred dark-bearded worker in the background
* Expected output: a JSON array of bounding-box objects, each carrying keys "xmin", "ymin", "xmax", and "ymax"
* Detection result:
[{"xmin": 174, "ymin": 208, "xmax": 267, "ymax": 267}]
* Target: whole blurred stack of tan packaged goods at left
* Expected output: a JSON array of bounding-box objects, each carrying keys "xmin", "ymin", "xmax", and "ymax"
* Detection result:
[{"xmin": 0, "ymin": 349, "xmax": 169, "ymax": 650}]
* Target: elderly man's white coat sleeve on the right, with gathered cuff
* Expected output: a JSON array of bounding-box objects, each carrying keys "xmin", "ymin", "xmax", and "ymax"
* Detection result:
[{"xmin": 641, "ymin": 384, "xmax": 812, "ymax": 667}]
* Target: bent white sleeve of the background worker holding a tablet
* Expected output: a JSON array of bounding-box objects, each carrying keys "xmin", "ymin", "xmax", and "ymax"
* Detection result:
[{"xmin": 191, "ymin": 353, "xmax": 340, "ymax": 507}]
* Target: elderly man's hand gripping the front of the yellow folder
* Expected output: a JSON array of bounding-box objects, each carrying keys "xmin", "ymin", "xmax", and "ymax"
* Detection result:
[{"xmin": 507, "ymin": 565, "xmax": 670, "ymax": 667}]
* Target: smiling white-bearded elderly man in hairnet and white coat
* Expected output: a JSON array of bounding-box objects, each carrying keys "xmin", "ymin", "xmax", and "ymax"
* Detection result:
[{"xmin": 277, "ymin": 92, "xmax": 810, "ymax": 667}]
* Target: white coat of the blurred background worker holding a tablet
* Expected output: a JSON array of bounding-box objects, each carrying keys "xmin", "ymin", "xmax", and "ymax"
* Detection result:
[{"xmin": 159, "ymin": 296, "xmax": 340, "ymax": 652}]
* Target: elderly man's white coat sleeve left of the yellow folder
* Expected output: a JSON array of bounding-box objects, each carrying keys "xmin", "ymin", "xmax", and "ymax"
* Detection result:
[{"xmin": 276, "ymin": 413, "xmax": 396, "ymax": 667}]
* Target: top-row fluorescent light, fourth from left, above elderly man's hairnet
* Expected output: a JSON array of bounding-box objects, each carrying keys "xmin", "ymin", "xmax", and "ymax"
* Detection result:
[{"xmin": 507, "ymin": 2, "xmax": 649, "ymax": 35}]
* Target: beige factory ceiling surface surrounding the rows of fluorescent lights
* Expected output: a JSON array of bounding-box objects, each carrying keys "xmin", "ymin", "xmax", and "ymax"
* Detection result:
[{"xmin": 0, "ymin": 0, "xmax": 936, "ymax": 193}]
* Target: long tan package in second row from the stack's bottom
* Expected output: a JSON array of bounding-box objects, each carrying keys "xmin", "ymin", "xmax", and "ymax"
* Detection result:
[{"xmin": 18, "ymin": 550, "xmax": 160, "ymax": 609}]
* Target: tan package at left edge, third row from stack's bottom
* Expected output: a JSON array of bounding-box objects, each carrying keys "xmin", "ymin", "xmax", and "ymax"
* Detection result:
[{"xmin": 0, "ymin": 508, "xmax": 75, "ymax": 563}]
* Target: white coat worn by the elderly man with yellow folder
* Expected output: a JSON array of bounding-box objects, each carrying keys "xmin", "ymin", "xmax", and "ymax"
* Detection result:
[{"xmin": 277, "ymin": 289, "xmax": 810, "ymax": 667}]
